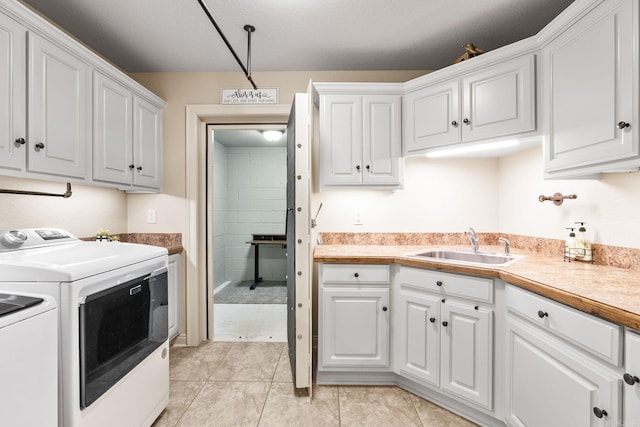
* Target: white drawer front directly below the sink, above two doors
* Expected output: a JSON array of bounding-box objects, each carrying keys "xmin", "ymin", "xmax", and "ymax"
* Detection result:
[{"xmin": 398, "ymin": 267, "xmax": 493, "ymax": 303}]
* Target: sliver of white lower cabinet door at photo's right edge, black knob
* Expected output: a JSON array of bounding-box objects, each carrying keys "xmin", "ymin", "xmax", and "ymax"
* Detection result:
[{"xmin": 624, "ymin": 332, "xmax": 640, "ymax": 426}]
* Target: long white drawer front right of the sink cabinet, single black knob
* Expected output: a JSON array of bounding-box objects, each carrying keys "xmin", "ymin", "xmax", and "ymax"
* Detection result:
[{"xmin": 505, "ymin": 285, "xmax": 622, "ymax": 366}]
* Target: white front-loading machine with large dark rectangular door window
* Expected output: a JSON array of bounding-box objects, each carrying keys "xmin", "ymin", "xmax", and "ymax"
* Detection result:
[{"xmin": 0, "ymin": 228, "xmax": 169, "ymax": 427}]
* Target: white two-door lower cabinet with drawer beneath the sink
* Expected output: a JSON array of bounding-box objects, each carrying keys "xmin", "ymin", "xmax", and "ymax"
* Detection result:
[{"xmin": 393, "ymin": 267, "xmax": 493, "ymax": 410}]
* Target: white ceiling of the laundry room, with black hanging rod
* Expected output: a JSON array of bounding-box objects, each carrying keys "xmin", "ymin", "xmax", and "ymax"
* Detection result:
[{"xmin": 21, "ymin": 0, "xmax": 572, "ymax": 74}]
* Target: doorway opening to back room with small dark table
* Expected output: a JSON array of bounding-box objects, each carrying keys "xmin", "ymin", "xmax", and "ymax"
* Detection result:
[{"xmin": 207, "ymin": 124, "xmax": 287, "ymax": 342}]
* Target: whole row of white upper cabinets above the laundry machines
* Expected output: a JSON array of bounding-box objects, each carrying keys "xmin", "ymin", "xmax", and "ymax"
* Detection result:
[{"xmin": 0, "ymin": 2, "xmax": 165, "ymax": 191}]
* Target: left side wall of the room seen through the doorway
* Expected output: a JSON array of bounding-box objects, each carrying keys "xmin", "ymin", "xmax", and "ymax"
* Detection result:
[{"xmin": 212, "ymin": 141, "xmax": 227, "ymax": 287}]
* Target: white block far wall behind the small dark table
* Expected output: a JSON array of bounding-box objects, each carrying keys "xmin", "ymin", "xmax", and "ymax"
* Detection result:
[{"xmin": 222, "ymin": 147, "xmax": 287, "ymax": 281}]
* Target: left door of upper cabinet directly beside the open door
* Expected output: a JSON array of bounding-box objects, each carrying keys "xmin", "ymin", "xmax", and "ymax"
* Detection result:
[{"xmin": 320, "ymin": 95, "xmax": 363, "ymax": 186}]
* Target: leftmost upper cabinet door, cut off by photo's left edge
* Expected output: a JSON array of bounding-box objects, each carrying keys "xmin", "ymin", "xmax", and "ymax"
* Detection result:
[{"xmin": 0, "ymin": 14, "xmax": 27, "ymax": 171}]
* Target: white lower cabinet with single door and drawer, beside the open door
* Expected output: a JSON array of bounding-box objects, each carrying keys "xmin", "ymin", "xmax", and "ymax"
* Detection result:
[{"xmin": 318, "ymin": 264, "xmax": 390, "ymax": 370}]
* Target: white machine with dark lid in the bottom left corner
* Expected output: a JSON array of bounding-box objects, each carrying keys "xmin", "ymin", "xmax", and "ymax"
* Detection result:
[{"xmin": 0, "ymin": 292, "xmax": 58, "ymax": 427}]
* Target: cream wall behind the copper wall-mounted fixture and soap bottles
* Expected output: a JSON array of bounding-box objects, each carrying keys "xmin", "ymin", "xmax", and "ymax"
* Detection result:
[{"xmin": 498, "ymin": 147, "xmax": 640, "ymax": 248}]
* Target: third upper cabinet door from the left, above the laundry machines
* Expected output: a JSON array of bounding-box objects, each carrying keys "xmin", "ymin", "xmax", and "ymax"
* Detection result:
[{"xmin": 93, "ymin": 72, "xmax": 134, "ymax": 185}]
